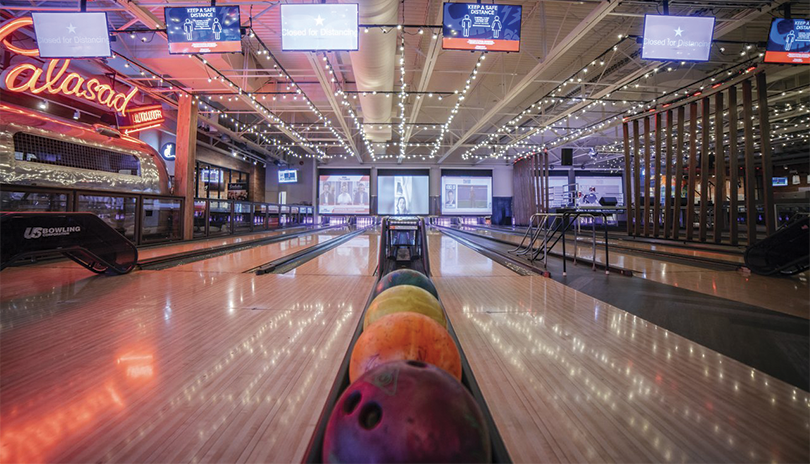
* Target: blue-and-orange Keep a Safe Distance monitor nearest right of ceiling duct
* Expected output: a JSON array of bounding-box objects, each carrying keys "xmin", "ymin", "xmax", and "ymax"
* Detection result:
[{"xmin": 442, "ymin": 3, "xmax": 523, "ymax": 52}]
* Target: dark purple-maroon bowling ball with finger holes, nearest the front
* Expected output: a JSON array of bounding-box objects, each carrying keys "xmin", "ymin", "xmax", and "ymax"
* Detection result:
[{"xmin": 322, "ymin": 361, "xmax": 491, "ymax": 462}]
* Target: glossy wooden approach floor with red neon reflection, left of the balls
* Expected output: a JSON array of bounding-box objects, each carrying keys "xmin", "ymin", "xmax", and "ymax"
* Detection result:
[{"xmin": 0, "ymin": 262, "xmax": 373, "ymax": 463}]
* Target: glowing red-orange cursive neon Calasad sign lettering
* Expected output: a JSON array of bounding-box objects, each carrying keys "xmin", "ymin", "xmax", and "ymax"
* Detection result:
[{"xmin": 0, "ymin": 17, "xmax": 138, "ymax": 116}]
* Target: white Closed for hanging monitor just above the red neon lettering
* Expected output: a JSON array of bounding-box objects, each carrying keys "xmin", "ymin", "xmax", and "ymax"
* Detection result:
[{"xmin": 31, "ymin": 12, "xmax": 112, "ymax": 58}]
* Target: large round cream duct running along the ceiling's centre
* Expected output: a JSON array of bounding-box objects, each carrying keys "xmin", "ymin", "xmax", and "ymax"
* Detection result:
[{"xmin": 351, "ymin": 0, "xmax": 399, "ymax": 142}]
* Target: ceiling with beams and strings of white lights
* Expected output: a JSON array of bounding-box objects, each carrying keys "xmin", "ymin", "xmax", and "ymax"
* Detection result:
[{"xmin": 0, "ymin": 0, "xmax": 810, "ymax": 168}]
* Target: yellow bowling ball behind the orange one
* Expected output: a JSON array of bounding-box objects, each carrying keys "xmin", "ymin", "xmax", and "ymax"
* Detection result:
[{"xmin": 363, "ymin": 285, "xmax": 447, "ymax": 329}]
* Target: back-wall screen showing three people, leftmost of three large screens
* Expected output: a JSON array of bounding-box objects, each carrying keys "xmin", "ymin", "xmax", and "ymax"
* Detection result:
[{"xmin": 318, "ymin": 175, "xmax": 369, "ymax": 214}]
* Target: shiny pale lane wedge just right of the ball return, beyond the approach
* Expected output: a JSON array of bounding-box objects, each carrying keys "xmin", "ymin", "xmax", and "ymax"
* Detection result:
[{"xmin": 428, "ymin": 231, "xmax": 515, "ymax": 277}]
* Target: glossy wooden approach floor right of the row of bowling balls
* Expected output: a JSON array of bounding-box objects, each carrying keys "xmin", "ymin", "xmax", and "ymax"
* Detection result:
[{"xmin": 434, "ymin": 270, "xmax": 810, "ymax": 462}]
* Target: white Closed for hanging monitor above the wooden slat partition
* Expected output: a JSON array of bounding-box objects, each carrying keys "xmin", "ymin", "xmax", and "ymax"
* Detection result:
[{"xmin": 641, "ymin": 15, "xmax": 714, "ymax": 61}]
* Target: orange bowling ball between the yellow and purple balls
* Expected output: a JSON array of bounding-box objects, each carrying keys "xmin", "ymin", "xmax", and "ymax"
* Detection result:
[{"xmin": 349, "ymin": 312, "xmax": 461, "ymax": 382}]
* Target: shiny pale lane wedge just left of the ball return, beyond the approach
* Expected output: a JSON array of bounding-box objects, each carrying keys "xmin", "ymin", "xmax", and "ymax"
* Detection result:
[{"xmin": 284, "ymin": 232, "xmax": 380, "ymax": 276}]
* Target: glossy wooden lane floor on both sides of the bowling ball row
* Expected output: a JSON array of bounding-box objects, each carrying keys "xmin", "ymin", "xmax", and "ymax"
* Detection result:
[{"xmin": 0, "ymin": 232, "xmax": 810, "ymax": 463}]
